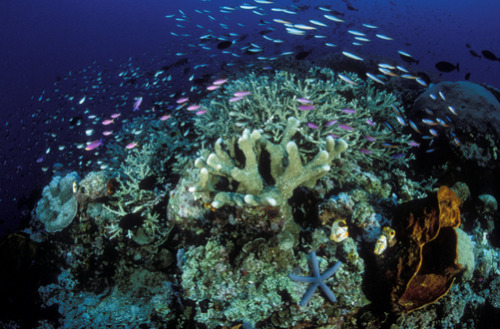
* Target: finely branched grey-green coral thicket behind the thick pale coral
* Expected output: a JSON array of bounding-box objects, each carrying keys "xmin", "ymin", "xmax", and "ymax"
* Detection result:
[{"xmin": 195, "ymin": 67, "xmax": 409, "ymax": 172}]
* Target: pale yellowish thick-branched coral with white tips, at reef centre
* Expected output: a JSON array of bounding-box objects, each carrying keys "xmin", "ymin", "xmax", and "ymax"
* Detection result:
[{"xmin": 192, "ymin": 117, "xmax": 347, "ymax": 214}]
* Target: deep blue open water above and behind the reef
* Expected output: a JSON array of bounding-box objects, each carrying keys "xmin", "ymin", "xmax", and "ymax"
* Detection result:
[{"xmin": 0, "ymin": 0, "xmax": 500, "ymax": 326}]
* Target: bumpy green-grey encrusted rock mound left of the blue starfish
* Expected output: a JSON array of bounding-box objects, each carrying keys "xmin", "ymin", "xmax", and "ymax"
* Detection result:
[{"xmin": 181, "ymin": 239, "xmax": 294, "ymax": 328}]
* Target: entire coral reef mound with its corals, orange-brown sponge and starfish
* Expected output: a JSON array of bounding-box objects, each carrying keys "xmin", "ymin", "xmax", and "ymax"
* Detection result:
[{"xmin": 9, "ymin": 63, "xmax": 500, "ymax": 329}]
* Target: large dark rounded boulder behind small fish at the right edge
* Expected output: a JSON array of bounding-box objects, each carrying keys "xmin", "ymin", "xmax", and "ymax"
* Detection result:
[{"xmin": 407, "ymin": 81, "xmax": 500, "ymax": 182}]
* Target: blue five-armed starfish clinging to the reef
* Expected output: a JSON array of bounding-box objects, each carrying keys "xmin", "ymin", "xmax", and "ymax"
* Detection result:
[{"xmin": 288, "ymin": 251, "xmax": 342, "ymax": 307}]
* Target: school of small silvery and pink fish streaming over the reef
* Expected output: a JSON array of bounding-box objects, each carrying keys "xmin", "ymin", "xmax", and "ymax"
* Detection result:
[{"xmin": 6, "ymin": 0, "xmax": 498, "ymax": 177}]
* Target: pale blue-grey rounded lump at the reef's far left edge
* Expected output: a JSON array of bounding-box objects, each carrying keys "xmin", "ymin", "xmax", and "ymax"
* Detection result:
[{"xmin": 36, "ymin": 172, "xmax": 80, "ymax": 233}]
